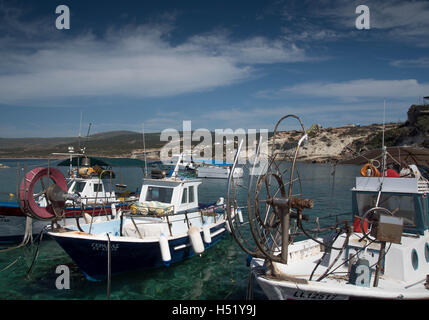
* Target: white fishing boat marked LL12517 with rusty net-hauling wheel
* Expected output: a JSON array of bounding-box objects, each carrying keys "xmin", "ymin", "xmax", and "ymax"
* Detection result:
[{"xmin": 227, "ymin": 114, "xmax": 429, "ymax": 300}]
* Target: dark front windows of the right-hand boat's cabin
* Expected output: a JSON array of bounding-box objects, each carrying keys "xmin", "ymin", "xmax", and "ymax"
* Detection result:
[{"xmin": 356, "ymin": 193, "xmax": 416, "ymax": 227}]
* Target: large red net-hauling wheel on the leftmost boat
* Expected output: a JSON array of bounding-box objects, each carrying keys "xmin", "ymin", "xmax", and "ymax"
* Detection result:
[{"xmin": 19, "ymin": 167, "xmax": 67, "ymax": 220}]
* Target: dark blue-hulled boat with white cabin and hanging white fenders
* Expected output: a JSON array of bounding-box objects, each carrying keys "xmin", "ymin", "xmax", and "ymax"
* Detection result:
[{"xmin": 48, "ymin": 158, "xmax": 237, "ymax": 280}]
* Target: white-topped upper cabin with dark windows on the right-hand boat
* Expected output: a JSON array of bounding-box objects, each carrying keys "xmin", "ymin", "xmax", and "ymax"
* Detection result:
[{"xmin": 352, "ymin": 177, "xmax": 429, "ymax": 235}]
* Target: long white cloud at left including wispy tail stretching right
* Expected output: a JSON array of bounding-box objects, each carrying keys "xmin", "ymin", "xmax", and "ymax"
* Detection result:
[{"xmin": 0, "ymin": 9, "xmax": 307, "ymax": 106}]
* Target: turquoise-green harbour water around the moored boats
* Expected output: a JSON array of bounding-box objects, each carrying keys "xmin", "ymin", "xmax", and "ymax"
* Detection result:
[{"xmin": 0, "ymin": 160, "xmax": 359, "ymax": 300}]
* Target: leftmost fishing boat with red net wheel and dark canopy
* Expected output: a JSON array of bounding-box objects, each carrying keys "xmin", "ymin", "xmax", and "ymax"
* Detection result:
[{"xmin": 0, "ymin": 152, "xmax": 145, "ymax": 243}]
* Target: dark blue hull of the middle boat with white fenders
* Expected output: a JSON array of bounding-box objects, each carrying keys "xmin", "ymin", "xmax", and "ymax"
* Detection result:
[{"xmin": 48, "ymin": 222, "xmax": 225, "ymax": 281}]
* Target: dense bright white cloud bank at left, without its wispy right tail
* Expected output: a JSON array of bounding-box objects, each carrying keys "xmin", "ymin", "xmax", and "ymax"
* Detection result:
[{"xmin": 0, "ymin": 28, "xmax": 250, "ymax": 103}]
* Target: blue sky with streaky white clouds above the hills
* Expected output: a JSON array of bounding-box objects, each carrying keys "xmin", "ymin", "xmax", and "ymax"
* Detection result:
[{"xmin": 0, "ymin": 0, "xmax": 429, "ymax": 138}]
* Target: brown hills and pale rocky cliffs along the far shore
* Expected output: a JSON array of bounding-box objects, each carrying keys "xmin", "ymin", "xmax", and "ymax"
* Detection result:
[{"xmin": 0, "ymin": 105, "xmax": 429, "ymax": 162}]
